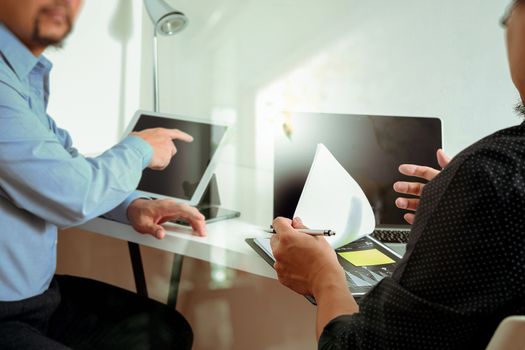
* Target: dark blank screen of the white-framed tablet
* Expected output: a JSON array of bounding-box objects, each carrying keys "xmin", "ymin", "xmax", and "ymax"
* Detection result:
[{"xmin": 133, "ymin": 114, "xmax": 227, "ymax": 201}]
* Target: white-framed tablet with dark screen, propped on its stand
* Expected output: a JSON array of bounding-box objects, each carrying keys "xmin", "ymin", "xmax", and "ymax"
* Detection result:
[{"xmin": 125, "ymin": 110, "xmax": 240, "ymax": 224}]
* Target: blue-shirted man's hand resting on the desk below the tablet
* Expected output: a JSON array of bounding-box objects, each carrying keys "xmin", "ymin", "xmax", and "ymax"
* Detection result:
[{"xmin": 128, "ymin": 199, "xmax": 206, "ymax": 239}]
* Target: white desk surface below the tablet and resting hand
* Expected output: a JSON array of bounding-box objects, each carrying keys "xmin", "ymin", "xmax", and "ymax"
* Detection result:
[{"xmin": 79, "ymin": 218, "xmax": 277, "ymax": 279}]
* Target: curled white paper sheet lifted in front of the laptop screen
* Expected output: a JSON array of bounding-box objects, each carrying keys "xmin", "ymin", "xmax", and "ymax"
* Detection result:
[{"xmin": 294, "ymin": 143, "xmax": 375, "ymax": 248}]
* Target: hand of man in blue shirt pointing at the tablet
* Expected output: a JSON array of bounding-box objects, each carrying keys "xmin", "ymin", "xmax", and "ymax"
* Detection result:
[{"xmin": 132, "ymin": 128, "xmax": 193, "ymax": 170}]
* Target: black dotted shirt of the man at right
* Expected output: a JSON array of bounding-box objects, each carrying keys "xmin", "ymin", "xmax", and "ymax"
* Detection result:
[{"xmin": 319, "ymin": 123, "xmax": 525, "ymax": 349}]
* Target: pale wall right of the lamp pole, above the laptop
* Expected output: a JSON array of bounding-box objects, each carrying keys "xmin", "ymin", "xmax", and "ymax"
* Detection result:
[{"xmin": 155, "ymin": 0, "xmax": 519, "ymax": 168}]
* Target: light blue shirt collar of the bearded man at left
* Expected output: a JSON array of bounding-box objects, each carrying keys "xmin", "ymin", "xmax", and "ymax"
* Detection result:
[{"xmin": 0, "ymin": 23, "xmax": 52, "ymax": 80}]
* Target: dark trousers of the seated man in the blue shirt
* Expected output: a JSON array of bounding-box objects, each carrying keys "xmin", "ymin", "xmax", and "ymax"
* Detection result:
[{"xmin": 0, "ymin": 276, "xmax": 193, "ymax": 350}]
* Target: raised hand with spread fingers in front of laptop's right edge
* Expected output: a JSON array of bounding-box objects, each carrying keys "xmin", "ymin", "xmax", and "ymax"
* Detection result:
[{"xmin": 394, "ymin": 149, "xmax": 450, "ymax": 225}]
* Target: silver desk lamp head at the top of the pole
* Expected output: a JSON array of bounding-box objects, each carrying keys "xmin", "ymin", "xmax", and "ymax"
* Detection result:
[{"xmin": 144, "ymin": 0, "xmax": 188, "ymax": 35}]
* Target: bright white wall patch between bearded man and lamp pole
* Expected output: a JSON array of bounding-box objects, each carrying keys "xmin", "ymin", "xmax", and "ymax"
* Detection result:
[{"xmin": 46, "ymin": 0, "xmax": 142, "ymax": 154}]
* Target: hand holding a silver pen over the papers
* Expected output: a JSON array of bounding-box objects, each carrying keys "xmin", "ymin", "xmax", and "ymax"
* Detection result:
[{"xmin": 270, "ymin": 218, "xmax": 347, "ymax": 297}]
